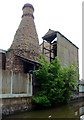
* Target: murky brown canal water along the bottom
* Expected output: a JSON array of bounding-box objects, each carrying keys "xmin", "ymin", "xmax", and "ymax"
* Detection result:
[{"xmin": 2, "ymin": 99, "xmax": 84, "ymax": 118}]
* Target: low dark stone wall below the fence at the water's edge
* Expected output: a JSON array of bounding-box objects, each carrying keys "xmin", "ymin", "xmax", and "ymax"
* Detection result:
[{"xmin": 2, "ymin": 97, "xmax": 32, "ymax": 115}]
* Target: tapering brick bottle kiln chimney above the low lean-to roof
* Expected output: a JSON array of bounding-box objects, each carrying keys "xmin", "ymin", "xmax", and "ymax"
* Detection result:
[{"xmin": 10, "ymin": 4, "xmax": 39, "ymax": 60}]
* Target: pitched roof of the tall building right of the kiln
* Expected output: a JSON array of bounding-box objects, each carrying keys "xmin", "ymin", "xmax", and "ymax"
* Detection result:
[{"xmin": 42, "ymin": 29, "xmax": 79, "ymax": 49}]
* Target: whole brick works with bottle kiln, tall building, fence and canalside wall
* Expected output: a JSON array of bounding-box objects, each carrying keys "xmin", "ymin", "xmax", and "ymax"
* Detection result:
[{"xmin": 0, "ymin": 4, "xmax": 78, "ymax": 114}]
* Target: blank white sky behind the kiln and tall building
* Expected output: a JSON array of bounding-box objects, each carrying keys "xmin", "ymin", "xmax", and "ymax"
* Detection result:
[{"xmin": 0, "ymin": 0, "xmax": 83, "ymax": 78}]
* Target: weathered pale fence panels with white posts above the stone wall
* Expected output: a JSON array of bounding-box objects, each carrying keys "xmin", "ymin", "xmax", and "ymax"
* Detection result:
[{"xmin": 0, "ymin": 70, "xmax": 32, "ymax": 97}]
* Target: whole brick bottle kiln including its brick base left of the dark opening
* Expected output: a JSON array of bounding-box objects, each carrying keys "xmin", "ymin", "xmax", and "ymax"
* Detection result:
[{"xmin": 6, "ymin": 4, "xmax": 40, "ymax": 72}]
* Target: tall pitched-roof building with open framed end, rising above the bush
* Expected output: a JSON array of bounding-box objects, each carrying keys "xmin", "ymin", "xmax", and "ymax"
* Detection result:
[{"xmin": 40, "ymin": 29, "xmax": 79, "ymax": 66}]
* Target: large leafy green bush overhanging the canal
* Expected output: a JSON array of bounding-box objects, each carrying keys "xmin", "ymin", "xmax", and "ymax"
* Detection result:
[{"xmin": 32, "ymin": 55, "xmax": 78, "ymax": 107}]
